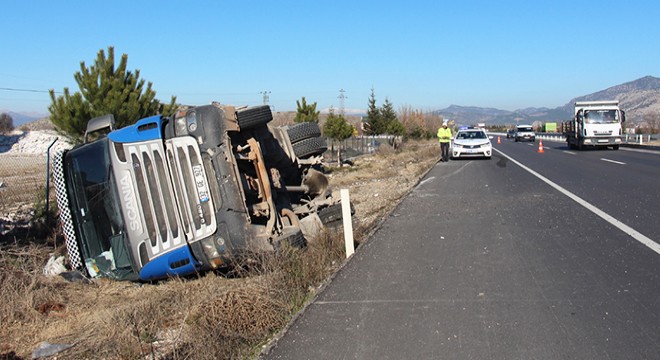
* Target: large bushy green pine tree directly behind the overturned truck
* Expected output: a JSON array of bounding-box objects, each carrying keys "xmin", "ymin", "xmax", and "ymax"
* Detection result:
[{"xmin": 48, "ymin": 47, "xmax": 176, "ymax": 141}]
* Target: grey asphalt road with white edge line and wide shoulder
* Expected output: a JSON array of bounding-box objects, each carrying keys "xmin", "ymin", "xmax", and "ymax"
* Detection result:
[{"xmin": 263, "ymin": 138, "xmax": 660, "ymax": 359}]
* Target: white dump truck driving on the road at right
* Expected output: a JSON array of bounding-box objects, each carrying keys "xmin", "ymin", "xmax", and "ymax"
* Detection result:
[{"xmin": 562, "ymin": 100, "xmax": 626, "ymax": 150}]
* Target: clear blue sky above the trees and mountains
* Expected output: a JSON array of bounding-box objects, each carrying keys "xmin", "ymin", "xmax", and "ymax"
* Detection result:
[{"xmin": 0, "ymin": 0, "xmax": 660, "ymax": 114}]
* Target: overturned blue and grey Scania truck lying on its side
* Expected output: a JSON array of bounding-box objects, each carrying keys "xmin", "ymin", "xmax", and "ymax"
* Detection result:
[{"xmin": 53, "ymin": 103, "xmax": 341, "ymax": 281}]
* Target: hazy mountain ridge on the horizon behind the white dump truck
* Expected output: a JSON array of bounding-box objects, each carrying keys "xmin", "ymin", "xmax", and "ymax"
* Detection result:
[{"xmin": 433, "ymin": 76, "xmax": 660, "ymax": 125}]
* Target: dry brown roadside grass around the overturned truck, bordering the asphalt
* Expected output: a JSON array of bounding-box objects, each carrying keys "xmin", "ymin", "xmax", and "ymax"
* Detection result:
[{"xmin": 0, "ymin": 139, "xmax": 437, "ymax": 359}]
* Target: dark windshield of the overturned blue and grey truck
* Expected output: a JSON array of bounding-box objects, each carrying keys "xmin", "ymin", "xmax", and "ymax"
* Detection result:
[{"xmin": 65, "ymin": 138, "xmax": 136, "ymax": 279}]
